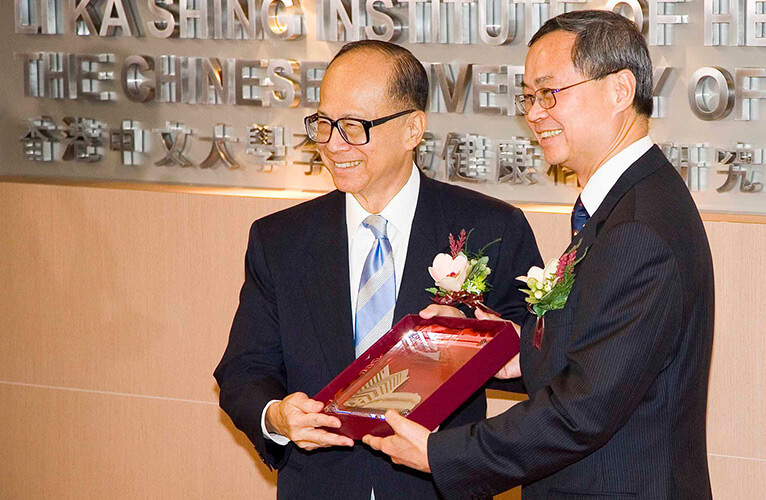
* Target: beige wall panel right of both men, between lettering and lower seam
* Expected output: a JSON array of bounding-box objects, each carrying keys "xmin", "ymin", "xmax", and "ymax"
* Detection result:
[{"xmin": 705, "ymin": 222, "xmax": 766, "ymax": 459}]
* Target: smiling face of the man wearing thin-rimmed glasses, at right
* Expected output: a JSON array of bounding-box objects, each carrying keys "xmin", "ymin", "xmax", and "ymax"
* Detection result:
[{"xmin": 524, "ymin": 31, "xmax": 620, "ymax": 180}]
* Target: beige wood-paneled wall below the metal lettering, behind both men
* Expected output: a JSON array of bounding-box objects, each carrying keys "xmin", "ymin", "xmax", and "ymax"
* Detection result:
[{"xmin": 0, "ymin": 182, "xmax": 766, "ymax": 499}]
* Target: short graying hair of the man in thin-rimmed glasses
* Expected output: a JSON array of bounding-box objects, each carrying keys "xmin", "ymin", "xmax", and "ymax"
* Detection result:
[{"xmin": 529, "ymin": 10, "xmax": 654, "ymax": 117}]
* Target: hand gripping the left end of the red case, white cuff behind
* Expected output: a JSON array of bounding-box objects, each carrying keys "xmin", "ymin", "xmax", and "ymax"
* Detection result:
[{"xmin": 266, "ymin": 392, "xmax": 354, "ymax": 450}]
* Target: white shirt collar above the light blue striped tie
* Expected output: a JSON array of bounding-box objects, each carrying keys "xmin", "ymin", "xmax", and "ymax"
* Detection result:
[{"xmin": 346, "ymin": 163, "xmax": 420, "ymax": 238}]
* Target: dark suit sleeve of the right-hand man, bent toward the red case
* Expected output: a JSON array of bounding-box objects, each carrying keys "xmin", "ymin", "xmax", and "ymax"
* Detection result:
[{"xmin": 428, "ymin": 222, "xmax": 682, "ymax": 498}]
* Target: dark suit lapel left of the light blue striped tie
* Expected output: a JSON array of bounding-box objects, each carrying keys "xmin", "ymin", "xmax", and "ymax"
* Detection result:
[{"xmin": 304, "ymin": 192, "xmax": 354, "ymax": 377}]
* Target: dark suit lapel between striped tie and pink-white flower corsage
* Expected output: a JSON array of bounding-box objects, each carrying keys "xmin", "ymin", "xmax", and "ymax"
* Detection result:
[{"xmin": 394, "ymin": 174, "xmax": 449, "ymax": 324}]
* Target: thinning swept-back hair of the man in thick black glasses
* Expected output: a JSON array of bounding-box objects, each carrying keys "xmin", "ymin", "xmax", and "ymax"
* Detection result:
[{"xmin": 328, "ymin": 40, "xmax": 428, "ymax": 111}]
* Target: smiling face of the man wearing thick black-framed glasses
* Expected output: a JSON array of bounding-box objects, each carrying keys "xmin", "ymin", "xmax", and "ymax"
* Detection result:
[{"xmin": 317, "ymin": 50, "xmax": 425, "ymax": 213}]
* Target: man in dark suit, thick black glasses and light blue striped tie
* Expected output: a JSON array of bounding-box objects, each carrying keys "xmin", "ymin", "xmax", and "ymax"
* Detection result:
[{"xmin": 215, "ymin": 41, "xmax": 540, "ymax": 500}]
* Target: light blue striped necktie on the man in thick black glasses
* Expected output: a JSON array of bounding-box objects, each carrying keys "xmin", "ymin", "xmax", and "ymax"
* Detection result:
[{"xmin": 354, "ymin": 215, "xmax": 396, "ymax": 357}]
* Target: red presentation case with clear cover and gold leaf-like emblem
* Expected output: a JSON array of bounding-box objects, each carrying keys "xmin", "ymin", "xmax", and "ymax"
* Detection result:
[{"xmin": 313, "ymin": 315, "xmax": 519, "ymax": 439}]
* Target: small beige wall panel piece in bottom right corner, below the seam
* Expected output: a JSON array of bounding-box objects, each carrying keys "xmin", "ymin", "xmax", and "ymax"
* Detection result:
[{"xmin": 708, "ymin": 456, "xmax": 766, "ymax": 500}]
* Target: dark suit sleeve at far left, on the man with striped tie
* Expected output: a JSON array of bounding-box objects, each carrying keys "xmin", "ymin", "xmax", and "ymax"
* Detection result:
[{"xmin": 215, "ymin": 221, "xmax": 291, "ymax": 468}]
